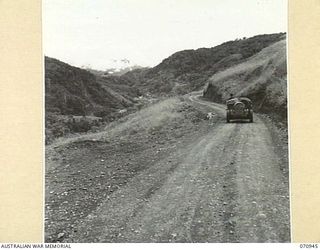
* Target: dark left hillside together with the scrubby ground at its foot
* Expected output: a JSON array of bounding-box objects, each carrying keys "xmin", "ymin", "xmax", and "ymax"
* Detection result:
[{"xmin": 45, "ymin": 57, "xmax": 139, "ymax": 142}]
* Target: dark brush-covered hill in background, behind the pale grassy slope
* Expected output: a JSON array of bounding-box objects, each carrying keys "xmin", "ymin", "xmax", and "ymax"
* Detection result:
[{"xmin": 123, "ymin": 33, "xmax": 285, "ymax": 95}]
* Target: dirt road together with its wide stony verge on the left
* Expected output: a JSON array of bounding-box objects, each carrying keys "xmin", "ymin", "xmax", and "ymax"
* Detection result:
[{"xmin": 46, "ymin": 95, "xmax": 290, "ymax": 242}]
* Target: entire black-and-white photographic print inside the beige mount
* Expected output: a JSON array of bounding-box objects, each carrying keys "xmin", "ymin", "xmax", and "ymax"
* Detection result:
[{"xmin": 42, "ymin": 0, "xmax": 291, "ymax": 243}]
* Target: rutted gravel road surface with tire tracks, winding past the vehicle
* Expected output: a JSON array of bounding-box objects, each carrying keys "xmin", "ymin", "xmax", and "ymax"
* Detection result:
[{"xmin": 62, "ymin": 95, "xmax": 289, "ymax": 242}]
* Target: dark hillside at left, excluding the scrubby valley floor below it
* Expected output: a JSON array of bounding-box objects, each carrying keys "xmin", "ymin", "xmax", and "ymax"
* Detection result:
[{"xmin": 45, "ymin": 57, "xmax": 138, "ymax": 115}]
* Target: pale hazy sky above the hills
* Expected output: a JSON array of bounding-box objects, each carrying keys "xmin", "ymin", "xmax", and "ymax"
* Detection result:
[{"xmin": 43, "ymin": 0, "xmax": 287, "ymax": 70}]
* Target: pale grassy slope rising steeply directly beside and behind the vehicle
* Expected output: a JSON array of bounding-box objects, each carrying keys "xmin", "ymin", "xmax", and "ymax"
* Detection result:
[{"xmin": 204, "ymin": 40, "xmax": 287, "ymax": 120}]
